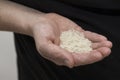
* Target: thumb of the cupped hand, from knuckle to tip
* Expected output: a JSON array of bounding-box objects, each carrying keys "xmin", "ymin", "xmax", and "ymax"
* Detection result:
[{"xmin": 39, "ymin": 40, "xmax": 74, "ymax": 68}]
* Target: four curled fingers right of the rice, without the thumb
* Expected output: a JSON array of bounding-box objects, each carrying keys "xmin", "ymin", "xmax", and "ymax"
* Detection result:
[{"xmin": 72, "ymin": 31, "xmax": 112, "ymax": 66}]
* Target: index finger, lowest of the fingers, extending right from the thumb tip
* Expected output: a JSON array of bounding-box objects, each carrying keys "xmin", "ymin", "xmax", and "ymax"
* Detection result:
[{"xmin": 73, "ymin": 50, "xmax": 103, "ymax": 66}]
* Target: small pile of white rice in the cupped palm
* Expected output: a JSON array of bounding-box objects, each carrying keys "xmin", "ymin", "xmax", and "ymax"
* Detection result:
[{"xmin": 60, "ymin": 29, "xmax": 92, "ymax": 53}]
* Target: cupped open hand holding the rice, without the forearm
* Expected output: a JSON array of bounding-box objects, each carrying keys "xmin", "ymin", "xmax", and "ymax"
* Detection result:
[{"xmin": 31, "ymin": 13, "xmax": 112, "ymax": 68}]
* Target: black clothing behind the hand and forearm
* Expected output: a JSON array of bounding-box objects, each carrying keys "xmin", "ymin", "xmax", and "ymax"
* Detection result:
[{"xmin": 11, "ymin": 0, "xmax": 120, "ymax": 80}]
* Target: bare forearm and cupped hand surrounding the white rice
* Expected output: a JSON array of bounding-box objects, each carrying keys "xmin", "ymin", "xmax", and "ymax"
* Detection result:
[{"xmin": 0, "ymin": 1, "xmax": 112, "ymax": 68}]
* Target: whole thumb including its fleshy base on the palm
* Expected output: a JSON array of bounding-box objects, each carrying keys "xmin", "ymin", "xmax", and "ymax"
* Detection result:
[{"xmin": 34, "ymin": 28, "xmax": 74, "ymax": 67}]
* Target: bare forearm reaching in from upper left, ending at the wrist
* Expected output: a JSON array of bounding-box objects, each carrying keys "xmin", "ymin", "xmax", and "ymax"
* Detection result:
[{"xmin": 0, "ymin": 1, "xmax": 43, "ymax": 34}]
